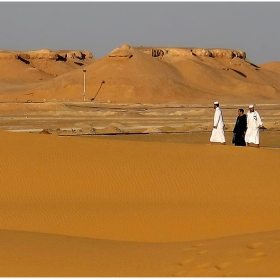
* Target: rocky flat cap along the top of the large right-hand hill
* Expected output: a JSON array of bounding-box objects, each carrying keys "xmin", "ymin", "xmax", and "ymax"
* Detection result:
[{"xmin": 134, "ymin": 46, "xmax": 246, "ymax": 59}]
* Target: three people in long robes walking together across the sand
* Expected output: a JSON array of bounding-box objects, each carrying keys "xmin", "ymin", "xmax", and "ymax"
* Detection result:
[{"xmin": 210, "ymin": 101, "xmax": 264, "ymax": 148}]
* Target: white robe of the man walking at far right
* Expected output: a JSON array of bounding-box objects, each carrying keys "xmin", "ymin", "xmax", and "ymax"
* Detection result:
[{"xmin": 245, "ymin": 111, "xmax": 263, "ymax": 145}]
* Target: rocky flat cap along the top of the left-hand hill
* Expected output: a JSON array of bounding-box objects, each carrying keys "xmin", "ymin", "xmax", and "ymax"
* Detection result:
[{"xmin": 0, "ymin": 49, "xmax": 93, "ymax": 61}]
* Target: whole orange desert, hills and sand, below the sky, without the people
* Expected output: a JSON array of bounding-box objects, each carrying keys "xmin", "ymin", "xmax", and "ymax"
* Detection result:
[{"xmin": 0, "ymin": 44, "xmax": 280, "ymax": 277}]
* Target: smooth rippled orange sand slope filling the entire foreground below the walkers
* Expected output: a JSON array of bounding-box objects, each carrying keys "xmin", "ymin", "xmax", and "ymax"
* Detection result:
[{"xmin": 0, "ymin": 131, "xmax": 280, "ymax": 276}]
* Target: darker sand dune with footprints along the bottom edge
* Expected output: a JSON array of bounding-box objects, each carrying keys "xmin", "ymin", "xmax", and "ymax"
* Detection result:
[{"xmin": 0, "ymin": 230, "xmax": 280, "ymax": 277}]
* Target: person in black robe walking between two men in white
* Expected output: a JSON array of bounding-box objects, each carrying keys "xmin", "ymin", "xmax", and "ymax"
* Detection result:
[{"xmin": 232, "ymin": 108, "xmax": 247, "ymax": 146}]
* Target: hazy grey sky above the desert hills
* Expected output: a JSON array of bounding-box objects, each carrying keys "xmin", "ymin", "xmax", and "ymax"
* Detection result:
[{"xmin": 0, "ymin": 2, "xmax": 280, "ymax": 64}]
